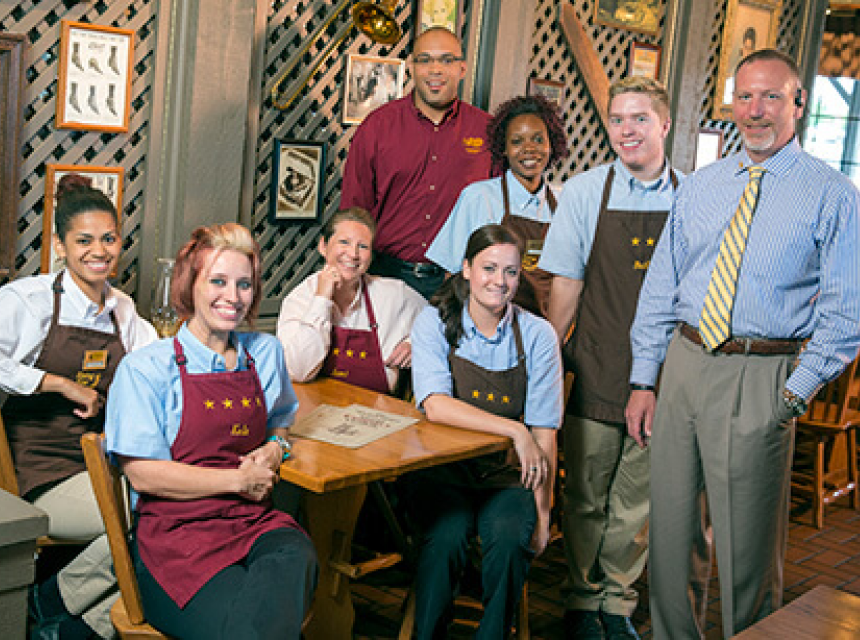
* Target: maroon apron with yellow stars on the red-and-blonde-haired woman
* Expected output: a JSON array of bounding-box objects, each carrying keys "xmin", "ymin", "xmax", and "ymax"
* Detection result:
[{"xmin": 137, "ymin": 338, "xmax": 298, "ymax": 607}]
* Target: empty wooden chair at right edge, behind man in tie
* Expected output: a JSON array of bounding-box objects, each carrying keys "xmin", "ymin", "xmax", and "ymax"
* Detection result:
[{"xmin": 791, "ymin": 360, "xmax": 860, "ymax": 529}]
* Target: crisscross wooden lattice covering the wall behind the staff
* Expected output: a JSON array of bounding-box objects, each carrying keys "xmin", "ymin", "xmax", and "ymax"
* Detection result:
[{"xmin": 0, "ymin": 0, "xmax": 803, "ymax": 315}]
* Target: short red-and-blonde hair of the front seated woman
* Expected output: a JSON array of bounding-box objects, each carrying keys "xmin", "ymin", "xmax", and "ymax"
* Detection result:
[{"xmin": 170, "ymin": 222, "xmax": 263, "ymax": 323}]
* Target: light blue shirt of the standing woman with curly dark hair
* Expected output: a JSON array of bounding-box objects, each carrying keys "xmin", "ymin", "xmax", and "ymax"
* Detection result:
[{"xmin": 426, "ymin": 169, "xmax": 554, "ymax": 273}]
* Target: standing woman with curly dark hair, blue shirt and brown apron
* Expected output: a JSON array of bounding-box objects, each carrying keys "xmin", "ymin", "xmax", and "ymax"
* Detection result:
[{"xmin": 427, "ymin": 96, "xmax": 568, "ymax": 316}]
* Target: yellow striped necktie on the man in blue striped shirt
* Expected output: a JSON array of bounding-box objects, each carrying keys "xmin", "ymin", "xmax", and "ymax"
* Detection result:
[{"xmin": 699, "ymin": 166, "xmax": 764, "ymax": 351}]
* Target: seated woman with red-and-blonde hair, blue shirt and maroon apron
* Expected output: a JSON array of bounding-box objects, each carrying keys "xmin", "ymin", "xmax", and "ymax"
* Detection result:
[{"xmin": 106, "ymin": 223, "xmax": 317, "ymax": 639}]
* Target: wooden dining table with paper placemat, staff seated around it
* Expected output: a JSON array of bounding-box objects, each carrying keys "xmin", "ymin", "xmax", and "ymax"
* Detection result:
[{"xmin": 281, "ymin": 378, "xmax": 511, "ymax": 640}]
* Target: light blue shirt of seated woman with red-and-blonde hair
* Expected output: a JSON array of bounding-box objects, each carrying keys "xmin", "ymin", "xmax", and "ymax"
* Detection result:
[{"xmin": 105, "ymin": 325, "xmax": 299, "ymax": 460}]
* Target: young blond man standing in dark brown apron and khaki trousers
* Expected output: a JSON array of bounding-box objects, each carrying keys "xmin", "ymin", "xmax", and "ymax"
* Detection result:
[{"xmin": 539, "ymin": 77, "xmax": 678, "ymax": 639}]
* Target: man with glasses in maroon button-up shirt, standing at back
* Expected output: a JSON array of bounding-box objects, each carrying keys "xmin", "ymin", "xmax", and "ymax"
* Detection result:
[{"xmin": 340, "ymin": 27, "xmax": 490, "ymax": 297}]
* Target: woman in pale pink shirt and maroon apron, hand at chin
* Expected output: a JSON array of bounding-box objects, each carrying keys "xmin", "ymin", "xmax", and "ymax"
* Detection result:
[{"xmin": 277, "ymin": 207, "xmax": 427, "ymax": 393}]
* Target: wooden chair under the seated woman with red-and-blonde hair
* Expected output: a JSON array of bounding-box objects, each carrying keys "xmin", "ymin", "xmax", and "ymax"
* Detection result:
[{"xmin": 81, "ymin": 433, "xmax": 167, "ymax": 640}]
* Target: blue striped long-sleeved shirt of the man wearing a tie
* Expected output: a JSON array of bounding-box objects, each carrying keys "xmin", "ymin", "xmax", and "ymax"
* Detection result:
[{"xmin": 630, "ymin": 140, "xmax": 860, "ymax": 398}]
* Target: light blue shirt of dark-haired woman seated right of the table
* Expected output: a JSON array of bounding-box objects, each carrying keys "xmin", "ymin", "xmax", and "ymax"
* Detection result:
[{"xmin": 411, "ymin": 304, "xmax": 563, "ymax": 429}]
